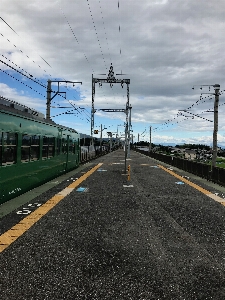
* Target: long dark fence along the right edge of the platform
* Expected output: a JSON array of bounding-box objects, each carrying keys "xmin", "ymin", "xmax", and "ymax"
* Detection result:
[{"xmin": 133, "ymin": 148, "xmax": 225, "ymax": 186}]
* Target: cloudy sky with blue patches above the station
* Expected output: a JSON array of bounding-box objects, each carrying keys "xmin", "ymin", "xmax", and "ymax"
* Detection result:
[{"xmin": 0, "ymin": 0, "xmax": 225, "ymax": 146}]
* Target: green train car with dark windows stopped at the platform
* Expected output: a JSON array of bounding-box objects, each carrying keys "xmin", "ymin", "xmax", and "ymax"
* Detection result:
[{"xmin": 0, "ymin": 101, "xmax": 80, "ymax": 204}]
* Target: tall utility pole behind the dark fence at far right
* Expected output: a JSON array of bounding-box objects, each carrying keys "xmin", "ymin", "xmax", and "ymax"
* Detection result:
[{"xmin": 212, "ymin": 84, "xmax": 220, "ymax": 168}]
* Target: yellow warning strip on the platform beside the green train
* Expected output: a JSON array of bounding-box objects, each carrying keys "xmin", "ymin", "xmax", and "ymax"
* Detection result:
[{"xmin": 0, "ymin": 163, "xmax": 102, "ymax": 253}]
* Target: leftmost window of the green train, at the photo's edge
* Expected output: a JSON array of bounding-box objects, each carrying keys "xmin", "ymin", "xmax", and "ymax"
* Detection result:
[{"xmin": 1, "ymin": 132, "xmax": 17, "ymax": 165}]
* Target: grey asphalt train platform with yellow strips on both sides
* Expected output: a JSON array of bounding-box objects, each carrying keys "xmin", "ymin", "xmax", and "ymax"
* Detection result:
[{"xmin": 0, "ymin": 149, "xmax": 225, "ymax": 300}]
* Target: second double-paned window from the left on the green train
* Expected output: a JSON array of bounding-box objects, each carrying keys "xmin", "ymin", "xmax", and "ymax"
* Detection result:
[{"xmin": 21, "ymin": 134, "xmax": 40, "ymax": 162}]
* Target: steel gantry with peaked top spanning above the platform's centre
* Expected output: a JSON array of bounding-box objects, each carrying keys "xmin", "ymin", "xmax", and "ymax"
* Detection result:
[{"xmin": 91, "ymin": 64, "xmax": 131, "ymax": 166}]
